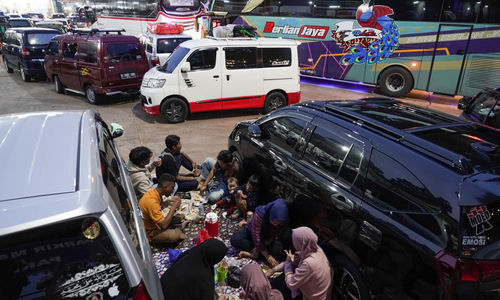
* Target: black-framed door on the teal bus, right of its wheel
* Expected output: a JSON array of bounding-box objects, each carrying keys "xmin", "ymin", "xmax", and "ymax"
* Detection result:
[{"xmin": 427, "ymin": 24, "xmax": 473, "ymax": 95}]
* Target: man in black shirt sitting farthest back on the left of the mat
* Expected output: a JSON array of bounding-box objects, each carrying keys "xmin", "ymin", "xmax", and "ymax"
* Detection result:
[{"xmin": 156, "ymin": 135, "xmax": 201, "ymax": 192}]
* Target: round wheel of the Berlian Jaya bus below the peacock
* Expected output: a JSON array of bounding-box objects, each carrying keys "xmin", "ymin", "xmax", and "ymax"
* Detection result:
[{"xmin": 378, "ymin": 67, "xmax": 413, "ymax": 97}]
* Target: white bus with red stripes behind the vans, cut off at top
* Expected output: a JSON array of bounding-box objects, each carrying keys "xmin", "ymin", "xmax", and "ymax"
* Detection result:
[{"xmin": 87, "ymin": 0, "xmax": 210, "ymax": 38}]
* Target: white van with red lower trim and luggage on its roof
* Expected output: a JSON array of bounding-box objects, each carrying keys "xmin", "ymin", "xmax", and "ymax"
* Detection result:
[{"xmin": 141, "ymin": 38, "xmax": 300, "ymax": 123}]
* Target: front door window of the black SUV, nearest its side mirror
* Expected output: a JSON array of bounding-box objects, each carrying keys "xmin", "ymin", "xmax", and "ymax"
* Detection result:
[{"xmin": 261, "ymin": 117, "xmax": 307, "ymax": 153}]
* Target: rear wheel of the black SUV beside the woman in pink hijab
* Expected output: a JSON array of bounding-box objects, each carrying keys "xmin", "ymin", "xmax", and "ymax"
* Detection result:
[{"xmin": 332, "ymin": 255, "xmax": 370, "ymax": 300}]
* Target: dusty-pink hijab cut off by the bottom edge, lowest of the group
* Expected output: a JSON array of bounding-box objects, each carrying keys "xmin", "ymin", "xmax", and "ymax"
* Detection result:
[{"xmin": 240, "ymin": 263, "xmax": 283, "ymax": 300}]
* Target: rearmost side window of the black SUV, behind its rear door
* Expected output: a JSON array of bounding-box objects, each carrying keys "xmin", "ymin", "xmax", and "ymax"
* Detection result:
[{"xmin": 364, "ymin": 150, "xmax": 438, "ymax": 213}]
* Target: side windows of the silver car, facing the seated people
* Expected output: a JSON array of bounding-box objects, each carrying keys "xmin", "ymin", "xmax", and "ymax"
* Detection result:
[{"xmin": 98, "ymin": 125, "xmax": 142, "ymax": 256}]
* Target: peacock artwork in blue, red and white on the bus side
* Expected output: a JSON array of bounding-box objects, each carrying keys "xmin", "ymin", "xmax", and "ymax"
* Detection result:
[{"xmin": 332, "ymin": 0, "xmax": 399, "ymax": 65}]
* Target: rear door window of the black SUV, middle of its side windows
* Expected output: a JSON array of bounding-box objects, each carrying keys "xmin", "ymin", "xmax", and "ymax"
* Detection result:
[{"xmin": 303, "ymin": 127, "xmax": 352, "ymax": 177}]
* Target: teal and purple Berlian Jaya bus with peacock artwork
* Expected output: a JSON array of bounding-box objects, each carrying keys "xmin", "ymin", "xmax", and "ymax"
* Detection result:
[{"xmin": 213, "ymin": 0, "xmax": 500, "ymax": 97}]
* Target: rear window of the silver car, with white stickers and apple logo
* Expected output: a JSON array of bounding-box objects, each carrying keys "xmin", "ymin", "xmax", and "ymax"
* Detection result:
[{"xmin": 0, "ymin": 218, "xmax": 130, "ymax": 300}]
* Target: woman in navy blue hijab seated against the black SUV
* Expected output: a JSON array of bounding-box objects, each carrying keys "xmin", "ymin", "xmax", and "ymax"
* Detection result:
[{"xmin": 231, "ymin": 198, "xmax": 289, "ymax": 267}]
